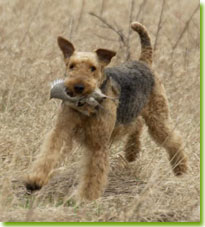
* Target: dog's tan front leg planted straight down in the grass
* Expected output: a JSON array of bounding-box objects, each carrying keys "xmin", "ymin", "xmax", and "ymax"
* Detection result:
[{"xmin": 79, "ymin": 100, "xmax": 116, "ymax": 200}]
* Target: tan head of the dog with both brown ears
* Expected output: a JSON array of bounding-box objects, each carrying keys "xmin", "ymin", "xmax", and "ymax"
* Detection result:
[{"xmin": 58, "ymin": 37, "xmax": 116, "ymax": 96}]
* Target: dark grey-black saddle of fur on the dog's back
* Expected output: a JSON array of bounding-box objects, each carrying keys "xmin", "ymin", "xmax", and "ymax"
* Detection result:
[{"xmin": 105, "ymin": 61, "xmax": 154, "ymax": 124}]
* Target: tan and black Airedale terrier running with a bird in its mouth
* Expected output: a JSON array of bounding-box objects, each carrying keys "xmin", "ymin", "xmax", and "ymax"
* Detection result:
[{"xmin": 26, "ymin": 22, "xmax": 187, "ymax": 200}]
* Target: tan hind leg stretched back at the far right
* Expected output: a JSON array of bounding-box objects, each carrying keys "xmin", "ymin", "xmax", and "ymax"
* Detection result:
[{"xmin": 143, "ymin": 79, "xmax": 187, "ymax": 176}]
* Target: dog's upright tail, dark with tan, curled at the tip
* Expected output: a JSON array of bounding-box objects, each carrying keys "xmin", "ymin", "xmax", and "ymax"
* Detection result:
[{"xmin": 131, "ymin": 22, "xmax": 152, "ymax": 65}]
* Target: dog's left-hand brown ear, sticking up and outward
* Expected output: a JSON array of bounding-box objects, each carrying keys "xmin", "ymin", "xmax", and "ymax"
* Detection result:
[{"xmin": 57, "ymin": 36, "xmax": 75, "ymax": 59}]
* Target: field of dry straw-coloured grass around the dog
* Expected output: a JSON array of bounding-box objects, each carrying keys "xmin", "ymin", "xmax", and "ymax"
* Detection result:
[{"xmin": 0, "ymin": 0, "xmax": 200, "ymax": 222}]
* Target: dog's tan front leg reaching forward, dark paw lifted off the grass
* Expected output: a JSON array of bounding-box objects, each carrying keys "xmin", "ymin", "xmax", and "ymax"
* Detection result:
[{"xmin": 25, "ymin": 106, "xmax": 75, "ymax": 190}]
